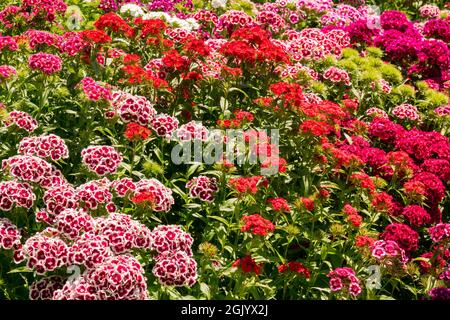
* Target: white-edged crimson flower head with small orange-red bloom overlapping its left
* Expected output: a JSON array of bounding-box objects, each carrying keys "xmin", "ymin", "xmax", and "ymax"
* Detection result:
[{"xmin": 134, "ymin": 178, "xmax": 175, "ymax": 212}]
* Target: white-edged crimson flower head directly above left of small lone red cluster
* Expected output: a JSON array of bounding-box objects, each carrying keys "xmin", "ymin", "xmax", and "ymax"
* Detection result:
[{"xmin": 113, "ymin": 92, "xmax": 156, "ymax": 126}]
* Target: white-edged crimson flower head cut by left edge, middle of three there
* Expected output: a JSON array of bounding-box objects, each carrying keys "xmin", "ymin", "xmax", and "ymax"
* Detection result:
[{"xmin": 0, "ymin": 181, "xmax": 36, "ymax": 211}]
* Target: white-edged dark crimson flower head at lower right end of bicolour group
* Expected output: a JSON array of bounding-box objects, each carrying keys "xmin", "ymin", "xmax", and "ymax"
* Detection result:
[{"xmin": 153, "ymin": 251, "xmax": 197, "ymax": 287}]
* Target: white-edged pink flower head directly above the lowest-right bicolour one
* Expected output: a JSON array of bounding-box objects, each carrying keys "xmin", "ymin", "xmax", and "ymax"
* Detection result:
[{"xmin": 151, "ymin": 225, "xmax": 194, "ymax": 256}]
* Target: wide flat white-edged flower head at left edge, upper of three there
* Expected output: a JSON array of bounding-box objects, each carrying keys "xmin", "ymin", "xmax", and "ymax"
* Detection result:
[{"xmin": 2, "ymin": 155, "xmax": 53, "ymax": 183}]
